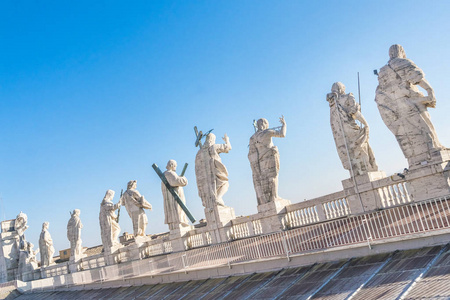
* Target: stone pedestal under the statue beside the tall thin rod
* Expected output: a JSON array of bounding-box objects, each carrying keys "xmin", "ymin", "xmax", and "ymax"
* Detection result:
[{"xmin": 342, "ymin": 171, "xmax": 386, "ymax": 214}]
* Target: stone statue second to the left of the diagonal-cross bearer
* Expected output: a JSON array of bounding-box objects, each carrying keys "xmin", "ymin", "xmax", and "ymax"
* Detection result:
[{"xmin": 99, "ymin": 190, "xmax": 122, "ymax": 250}]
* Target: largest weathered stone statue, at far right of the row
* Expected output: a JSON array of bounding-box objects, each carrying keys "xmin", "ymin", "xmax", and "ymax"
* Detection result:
[{"xmin": 375, "ymin": 45, "xmax": 444, "ymax": 166}]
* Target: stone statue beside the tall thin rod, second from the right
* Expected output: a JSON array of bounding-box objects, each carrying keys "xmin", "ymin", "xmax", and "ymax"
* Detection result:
[{"xmin": 327, "ymin": 82, "xmax": 378, "ymax": 175}]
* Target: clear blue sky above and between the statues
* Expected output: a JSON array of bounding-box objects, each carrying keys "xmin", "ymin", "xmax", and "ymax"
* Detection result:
[{"xmin": 0, "ymin": 0, "xmax": 450, "ymax": 256}]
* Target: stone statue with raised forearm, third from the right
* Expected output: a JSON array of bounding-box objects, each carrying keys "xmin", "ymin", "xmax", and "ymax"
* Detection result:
[{"xmin": 248, "ymin": 116, "xmax": 286, "ymax": 205}]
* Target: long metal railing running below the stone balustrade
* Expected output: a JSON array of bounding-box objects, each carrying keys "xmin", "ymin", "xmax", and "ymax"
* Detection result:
[{"xmin": 23, "ymin": 196, "xmax": 450, "ymax": 287}]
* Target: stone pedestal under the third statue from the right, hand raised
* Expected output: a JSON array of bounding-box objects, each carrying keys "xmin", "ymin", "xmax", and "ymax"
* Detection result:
[{"xmin": 258, "ymin": 198, "xmax": 291, "ymax": 234}]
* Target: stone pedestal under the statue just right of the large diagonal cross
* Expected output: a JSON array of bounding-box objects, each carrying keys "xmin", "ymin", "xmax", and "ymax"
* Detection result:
[{"xmin": 205, "ymin": 205, "xmax": 236, "ymax": 244}]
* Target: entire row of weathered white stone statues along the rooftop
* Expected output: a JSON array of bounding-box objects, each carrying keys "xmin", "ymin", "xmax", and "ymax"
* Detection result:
[{"xmin": 8, "ymin": 45, "xmax": 444, "ymax": 270}]
